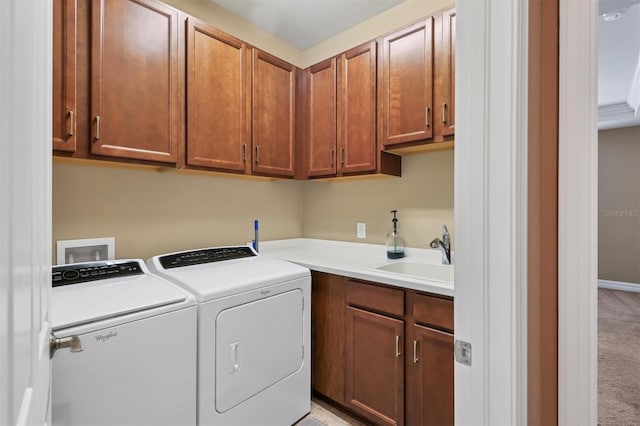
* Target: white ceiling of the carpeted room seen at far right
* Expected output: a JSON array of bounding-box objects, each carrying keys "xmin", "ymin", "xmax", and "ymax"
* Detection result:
[{"xmin": 598, "ymin": 0, "xmax": 640, "ymax": 129}]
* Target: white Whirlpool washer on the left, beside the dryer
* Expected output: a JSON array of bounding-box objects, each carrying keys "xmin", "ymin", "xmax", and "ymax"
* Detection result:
[{"xmin": 51, "ymin": 260, "xmax": 197, "ymax": 426}]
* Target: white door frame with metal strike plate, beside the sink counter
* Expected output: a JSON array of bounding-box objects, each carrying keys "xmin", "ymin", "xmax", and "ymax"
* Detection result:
[{"xmin": 455, "ymin": 0, "xmax": 529, "ymax": 425}]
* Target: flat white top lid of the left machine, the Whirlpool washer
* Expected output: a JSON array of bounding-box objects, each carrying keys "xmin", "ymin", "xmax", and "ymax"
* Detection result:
[{"xmin": 51, "ymin": 274, "xmax": 188, "ymax": 330}]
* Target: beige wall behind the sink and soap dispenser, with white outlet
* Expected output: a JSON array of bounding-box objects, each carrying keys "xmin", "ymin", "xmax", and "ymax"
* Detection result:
[{"xmin": 304, "ymin": 150, "xmax": 453, "ymax": 248}]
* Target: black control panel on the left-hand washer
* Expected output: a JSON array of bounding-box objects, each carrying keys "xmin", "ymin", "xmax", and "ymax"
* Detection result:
[{"xmin": 51, "ymin": 260, "xmax": 144, "ymax": 287}]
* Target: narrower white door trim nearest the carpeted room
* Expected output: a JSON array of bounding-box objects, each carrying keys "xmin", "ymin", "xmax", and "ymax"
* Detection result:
[{"xmin": 558, "ymin": 0, "xmax": 598, "ymax": 425}]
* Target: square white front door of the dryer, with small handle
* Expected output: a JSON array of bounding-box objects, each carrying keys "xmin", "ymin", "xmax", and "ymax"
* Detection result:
[{"xmin": 216, "ymin": 289, "xmax": 303, "ymax": 413}]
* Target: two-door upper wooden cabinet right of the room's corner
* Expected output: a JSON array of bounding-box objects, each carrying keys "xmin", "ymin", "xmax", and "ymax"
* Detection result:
[{"xmin": 300, "ymin": 42, "xmax": 400, "ymax": 177}]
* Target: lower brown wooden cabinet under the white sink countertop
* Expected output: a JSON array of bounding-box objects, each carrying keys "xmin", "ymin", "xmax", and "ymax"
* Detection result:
[{"xmin": 311, "ymin": 272, "xmax": 454, "ymax": 426}]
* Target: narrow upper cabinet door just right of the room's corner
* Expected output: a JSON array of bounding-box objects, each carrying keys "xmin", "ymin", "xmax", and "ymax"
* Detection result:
[{"xmin": 306, "ymin": 58, "xmax": 337, "ymax": 176}]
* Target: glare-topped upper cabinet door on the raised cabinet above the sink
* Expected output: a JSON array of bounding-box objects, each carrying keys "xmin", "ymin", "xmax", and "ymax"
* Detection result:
[{"xmin": 379, "ymin": 17, "xmax": 433, "ymax": 147}]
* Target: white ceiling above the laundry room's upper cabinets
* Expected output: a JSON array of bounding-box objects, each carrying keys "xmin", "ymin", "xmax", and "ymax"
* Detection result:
[{"xmin": 211, "ymin": 0, "xmax": 406, "ymax": 50}]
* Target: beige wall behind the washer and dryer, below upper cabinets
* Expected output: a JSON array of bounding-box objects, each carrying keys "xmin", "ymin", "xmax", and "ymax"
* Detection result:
[{"xmin": 53, "ymin": 163, "xmax": 304, "ymax": 262}]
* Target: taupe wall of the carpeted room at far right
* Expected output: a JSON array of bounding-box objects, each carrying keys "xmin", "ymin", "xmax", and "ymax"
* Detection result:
[{"xmin": 598, "ymin": 127, "xmax": 640, "ymax": 284}]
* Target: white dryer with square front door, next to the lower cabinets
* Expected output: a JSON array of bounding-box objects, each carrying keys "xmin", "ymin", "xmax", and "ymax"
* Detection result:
[{"xmin": 147, "ymin": 246, "xmax": 311, "ymax": 426}]
